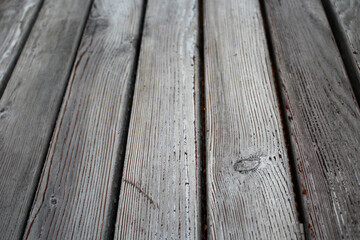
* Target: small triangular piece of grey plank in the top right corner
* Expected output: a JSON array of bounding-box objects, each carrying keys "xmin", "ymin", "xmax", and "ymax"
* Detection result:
[{"xmin": 323, "ymin": 0, "xmax": 360, "ymax": 95}]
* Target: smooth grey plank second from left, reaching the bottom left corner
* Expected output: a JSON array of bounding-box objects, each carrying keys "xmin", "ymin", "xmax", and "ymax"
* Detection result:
[{"xmin": 0, "ymin": 0, "xmax": 91, "ymax": 239}]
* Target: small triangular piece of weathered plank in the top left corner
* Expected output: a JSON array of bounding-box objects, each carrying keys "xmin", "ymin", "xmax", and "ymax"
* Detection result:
[{"xmin": 0, "ymin": 0, "xmax": 42, "ymax": 96}]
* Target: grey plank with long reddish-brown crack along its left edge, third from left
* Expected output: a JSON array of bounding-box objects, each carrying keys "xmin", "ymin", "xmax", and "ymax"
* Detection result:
[{"xmin": 22, "ymin": 0, "xmax": 143, "ymax": 239}]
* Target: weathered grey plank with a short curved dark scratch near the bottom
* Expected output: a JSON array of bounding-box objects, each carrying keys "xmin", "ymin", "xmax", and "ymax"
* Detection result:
[{"xmin": 115, "ymin": 0, "xmax": 201, "ymax": 239}]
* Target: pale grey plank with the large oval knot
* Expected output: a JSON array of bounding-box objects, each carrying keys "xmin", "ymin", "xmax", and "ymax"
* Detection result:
[{"xmin": 204, "ymin": 0, "xmax": 301, "ymax": 239}]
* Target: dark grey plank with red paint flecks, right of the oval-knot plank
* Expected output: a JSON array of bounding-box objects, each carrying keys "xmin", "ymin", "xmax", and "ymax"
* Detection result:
[{"xmin": 265, "ymin": 0, "xmax": 360, "ymax": 239}]
